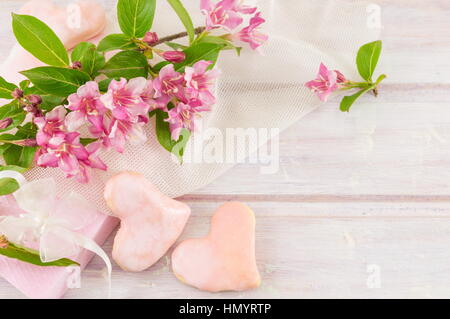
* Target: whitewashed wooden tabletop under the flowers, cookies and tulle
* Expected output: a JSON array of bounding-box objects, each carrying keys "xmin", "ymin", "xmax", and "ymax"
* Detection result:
[{"xmin": 0, "ymin": 0, "xmax": 450, "ymax": 299}]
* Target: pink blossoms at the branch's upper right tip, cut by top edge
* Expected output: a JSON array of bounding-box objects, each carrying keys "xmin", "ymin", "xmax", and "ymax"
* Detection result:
[{"xmin": 201, "ymin": 0, "xmax": 269, "ymax": 50}]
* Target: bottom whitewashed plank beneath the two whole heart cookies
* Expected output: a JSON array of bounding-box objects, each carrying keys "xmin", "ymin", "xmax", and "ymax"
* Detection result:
[{"xmin": 0, "ymin": 202, "xmax": 450, "ymax": 298}]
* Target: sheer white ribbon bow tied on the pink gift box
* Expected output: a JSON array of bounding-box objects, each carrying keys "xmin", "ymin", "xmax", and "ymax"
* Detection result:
[{"xmin": 0, "ymin": 171, "xmax": 112, "ymax": 282}]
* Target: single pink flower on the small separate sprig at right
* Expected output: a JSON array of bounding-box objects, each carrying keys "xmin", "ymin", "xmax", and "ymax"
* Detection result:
[{"xmin": 305, "ymin": 63, "xmax": 346, "ymax": 102}]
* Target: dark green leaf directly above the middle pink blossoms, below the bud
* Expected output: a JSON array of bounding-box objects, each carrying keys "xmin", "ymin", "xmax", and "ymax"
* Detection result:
[{"xmin": 100, "ymin": 51, "xmax": 148, "ymax": 80}]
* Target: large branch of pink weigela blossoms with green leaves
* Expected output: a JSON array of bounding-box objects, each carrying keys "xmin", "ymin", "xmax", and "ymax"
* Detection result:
[{"xmin": 0, "ymin": 0, "xmax": 268, "ymax": 188}]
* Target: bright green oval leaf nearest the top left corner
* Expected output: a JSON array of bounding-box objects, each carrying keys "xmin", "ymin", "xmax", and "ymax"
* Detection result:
[{"xmin": 12, "ymin": 13, "xmax": 69, "ymax": 67}]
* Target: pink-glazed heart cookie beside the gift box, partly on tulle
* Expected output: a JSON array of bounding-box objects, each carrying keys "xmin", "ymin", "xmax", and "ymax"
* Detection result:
[{"xmin": 105, "ymin": 172, "xmax": 191, "ymax": 272}]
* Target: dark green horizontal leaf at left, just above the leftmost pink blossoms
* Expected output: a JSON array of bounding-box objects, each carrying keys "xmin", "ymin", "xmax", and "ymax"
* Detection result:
[{"xmin": 20, "ymin": 66, "xmax": 91, "ymax": 97}]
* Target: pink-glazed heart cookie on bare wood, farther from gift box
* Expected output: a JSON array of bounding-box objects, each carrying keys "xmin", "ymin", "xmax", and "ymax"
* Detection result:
[{"xmin": 172, "ymin": 202, "xmax": 261, "ymax": 292}]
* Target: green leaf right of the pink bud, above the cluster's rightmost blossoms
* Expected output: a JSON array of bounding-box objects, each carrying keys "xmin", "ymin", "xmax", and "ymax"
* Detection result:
[{"xmin": 175, "ymin": 43, "xmax": 224, "ymax": 72}]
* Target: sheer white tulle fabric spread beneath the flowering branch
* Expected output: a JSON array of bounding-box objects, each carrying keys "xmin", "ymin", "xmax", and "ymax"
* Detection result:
[{"xmin": 22, "ymin": 0, "xmax": 377, "ymax": 212}]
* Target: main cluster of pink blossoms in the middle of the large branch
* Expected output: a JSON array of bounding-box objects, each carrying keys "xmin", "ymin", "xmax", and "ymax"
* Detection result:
[{"xmin": 34, "ymin": 60, "xmax": 219, "ymax": 182}]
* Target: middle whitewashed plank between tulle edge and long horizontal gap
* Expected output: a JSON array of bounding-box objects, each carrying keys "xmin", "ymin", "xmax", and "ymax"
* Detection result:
[{"xmin": 194, "ymin": 101, "xmax": 450, "ymax": 197}]
